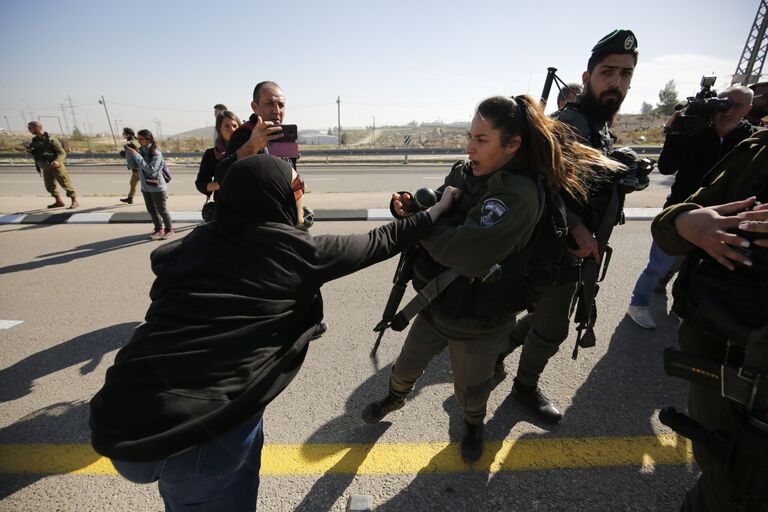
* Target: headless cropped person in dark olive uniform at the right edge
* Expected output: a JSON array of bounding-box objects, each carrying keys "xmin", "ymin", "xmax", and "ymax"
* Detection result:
[{"xmin": 652, "ymin": 130, "xmax": 768, "ymax": 512}]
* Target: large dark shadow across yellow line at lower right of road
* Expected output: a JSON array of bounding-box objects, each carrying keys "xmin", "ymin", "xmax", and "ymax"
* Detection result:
[{"xmin": 377, "ymin": 300, "xmax": 696, "ymax": 512}]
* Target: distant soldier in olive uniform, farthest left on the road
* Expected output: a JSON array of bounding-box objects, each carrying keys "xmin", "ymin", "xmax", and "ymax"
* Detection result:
[{"xmin": 27, "ymin": 121, "xmax": 80, "ymax": 210}]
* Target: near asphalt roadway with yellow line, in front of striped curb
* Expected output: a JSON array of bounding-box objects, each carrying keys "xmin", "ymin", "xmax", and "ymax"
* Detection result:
[{"xmin": 0, "ymin": 219, "xmax": 696, "ymax": 511}]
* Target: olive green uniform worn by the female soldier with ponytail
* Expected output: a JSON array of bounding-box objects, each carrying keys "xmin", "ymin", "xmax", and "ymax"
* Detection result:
[{"xmin": 389, "ymin": 155, "xmax": 539, "ymax": 424}]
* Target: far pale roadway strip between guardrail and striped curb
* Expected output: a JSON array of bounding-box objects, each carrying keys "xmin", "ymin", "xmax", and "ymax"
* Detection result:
[{"xmin": 0, "ymin": 164, "xmax": 673, "ymax": 206}]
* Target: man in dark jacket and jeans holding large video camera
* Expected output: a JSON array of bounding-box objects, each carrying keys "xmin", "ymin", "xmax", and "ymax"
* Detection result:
[{"xmin": 627, "ymin": 86, "xmax": 758, "ymax": 329}]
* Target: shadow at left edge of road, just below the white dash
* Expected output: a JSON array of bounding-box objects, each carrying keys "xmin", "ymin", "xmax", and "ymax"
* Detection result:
[{"xmin": 0, "ymin": 322, "xmax": 139, "ymax": 403}]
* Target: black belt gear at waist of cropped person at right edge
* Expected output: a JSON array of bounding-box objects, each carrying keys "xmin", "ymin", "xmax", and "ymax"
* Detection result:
[{"xmin": 664, "ymin": 348, "xmax": 768, "ymax": 431}]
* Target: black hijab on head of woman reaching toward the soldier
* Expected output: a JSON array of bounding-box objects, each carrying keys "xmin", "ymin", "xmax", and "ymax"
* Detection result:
[{"xmin": 216, "ymin": 154, "xmax": 299, "ymax": 231}]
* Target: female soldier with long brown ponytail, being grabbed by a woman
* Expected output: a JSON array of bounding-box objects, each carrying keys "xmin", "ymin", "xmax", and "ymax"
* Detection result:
[{"xmin": 362, "ymin": 96, "xmax": 619, "ymax": 462}]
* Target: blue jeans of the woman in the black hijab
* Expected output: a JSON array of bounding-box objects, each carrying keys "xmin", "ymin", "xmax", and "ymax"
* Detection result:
[{"xmin": 112, "ymin": 417, "xmax": 264, "ymax": 512}]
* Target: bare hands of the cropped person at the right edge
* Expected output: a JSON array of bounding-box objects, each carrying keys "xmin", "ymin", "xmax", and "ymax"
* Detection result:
[{"xmin": 675, "ymin": 197, "xmax": 756, "ymax": 270}]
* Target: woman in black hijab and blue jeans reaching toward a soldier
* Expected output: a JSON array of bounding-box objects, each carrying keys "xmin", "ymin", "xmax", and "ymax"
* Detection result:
[{"xmin": 90, "ymin": 155, "xmax": 460, "ymax": 510}]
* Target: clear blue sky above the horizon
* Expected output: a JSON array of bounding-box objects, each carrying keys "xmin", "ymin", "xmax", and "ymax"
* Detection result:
[{"xmin": 0, "ymin": 0, "xmax": 756, "ymax": 136}]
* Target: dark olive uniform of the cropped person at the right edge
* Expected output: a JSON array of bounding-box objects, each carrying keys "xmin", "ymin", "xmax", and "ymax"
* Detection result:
[{"xmin": 652, "ymin": 131, "xmax": 768, "ymax": 512}]
